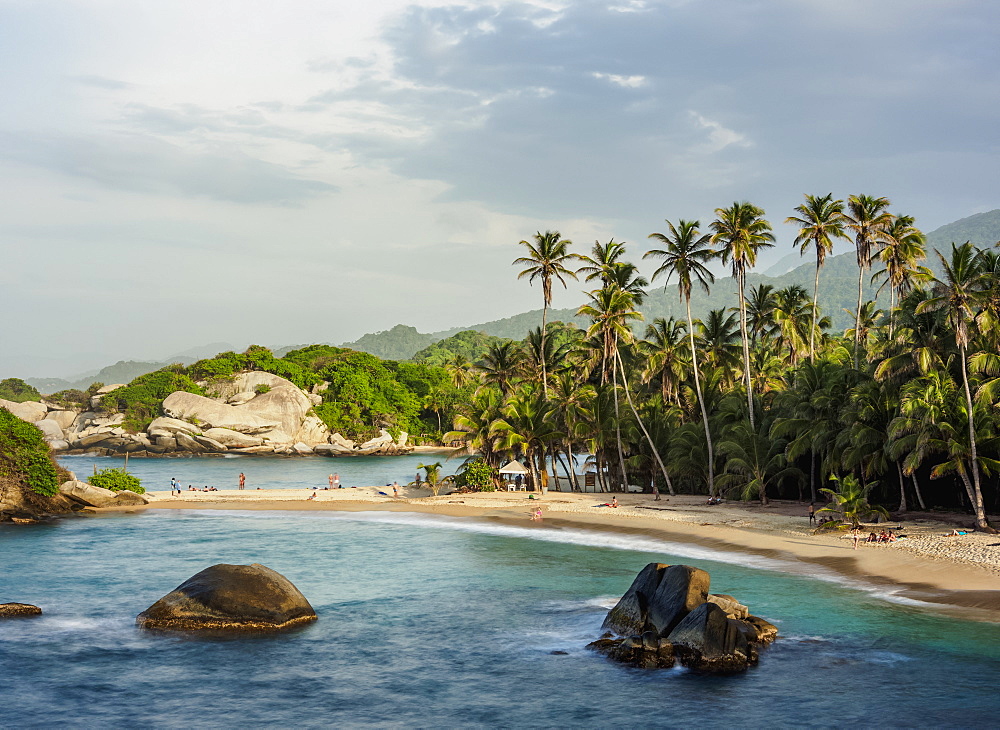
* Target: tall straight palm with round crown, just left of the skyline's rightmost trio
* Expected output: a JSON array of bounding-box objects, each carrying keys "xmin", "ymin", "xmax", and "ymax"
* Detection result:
[{"xmin": 711, "ymin": 201, "xmax": 774, "ymax": 426}]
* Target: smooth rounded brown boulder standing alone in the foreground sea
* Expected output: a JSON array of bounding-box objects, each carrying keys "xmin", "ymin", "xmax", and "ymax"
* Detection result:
[{"xmin": 135, "ymin": 563, "xmax": 317, "ymax": 631}]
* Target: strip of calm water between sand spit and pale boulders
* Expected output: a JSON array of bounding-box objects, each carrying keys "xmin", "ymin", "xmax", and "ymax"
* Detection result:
[{"xmin": 59, "ymin": 453, "xmax": 463, "ymax": 491}]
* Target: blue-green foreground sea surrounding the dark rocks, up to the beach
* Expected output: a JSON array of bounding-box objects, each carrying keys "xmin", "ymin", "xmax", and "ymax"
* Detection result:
[{"xmin": 0, "ymin": 504, "xmax": 1000, "ymax": 728}]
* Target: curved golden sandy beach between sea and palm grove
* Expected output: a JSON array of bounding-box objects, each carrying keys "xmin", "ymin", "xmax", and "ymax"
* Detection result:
[{"xmin": 129, "ymin": 487, "xmax": 1000, "ymax": 622}]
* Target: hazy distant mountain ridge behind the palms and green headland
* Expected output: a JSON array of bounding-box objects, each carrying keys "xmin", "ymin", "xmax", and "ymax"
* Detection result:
[{"xmin": 19, "ymin": 209, "xmax": 1000, "ymax": 393}]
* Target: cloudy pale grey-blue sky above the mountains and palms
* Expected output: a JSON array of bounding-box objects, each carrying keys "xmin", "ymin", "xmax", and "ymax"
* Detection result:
[{"xmin": 0, "ymin": 0, "xmax": 1000, "ymax": 378}]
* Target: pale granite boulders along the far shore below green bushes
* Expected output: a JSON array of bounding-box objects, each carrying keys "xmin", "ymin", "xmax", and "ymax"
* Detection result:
[{"xmin": 0, "ymin": 371, "xmax": 413, "ymax": 456}]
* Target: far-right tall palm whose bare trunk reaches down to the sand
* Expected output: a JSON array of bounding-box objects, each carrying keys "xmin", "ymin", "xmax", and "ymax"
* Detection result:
[{"xmin": 917, "ymin": 242, "xmax": 995, "ymax": 532}]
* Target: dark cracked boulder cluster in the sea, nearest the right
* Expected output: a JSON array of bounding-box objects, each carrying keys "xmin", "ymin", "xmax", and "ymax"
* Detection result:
[{"xmin": 589, "ymin": 563, "xmax": 778, "ymax": 673}]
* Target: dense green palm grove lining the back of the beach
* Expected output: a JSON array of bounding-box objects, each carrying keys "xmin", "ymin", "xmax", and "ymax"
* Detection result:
[{"xmin": 445, "ymin": 194, "xmax": 1000, "ymax": 529}]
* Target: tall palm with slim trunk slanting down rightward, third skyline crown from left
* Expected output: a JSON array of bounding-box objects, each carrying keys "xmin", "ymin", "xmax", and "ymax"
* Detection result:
[{"xmin": 643, "ymin": 219, "xmax": 715, "ymax": 496}]
